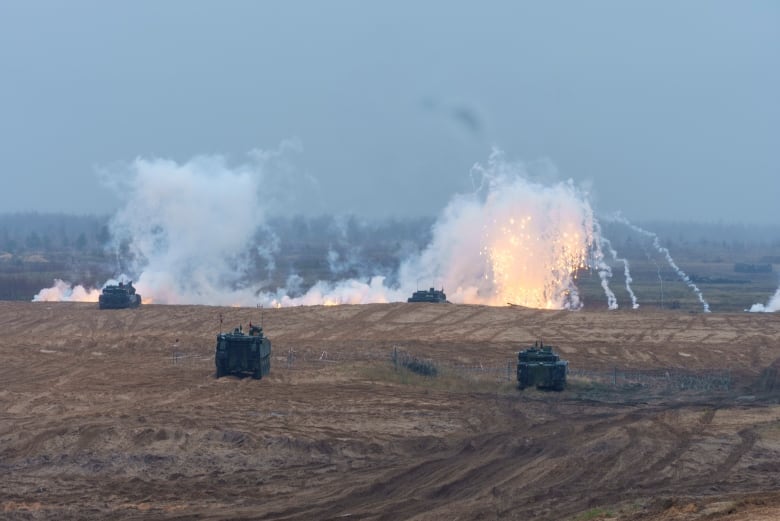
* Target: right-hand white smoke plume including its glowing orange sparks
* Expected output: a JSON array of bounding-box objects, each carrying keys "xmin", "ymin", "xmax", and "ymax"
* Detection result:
[{"xmin": 400, "ymin": 151, "xmax": 594, "ymax": 309}]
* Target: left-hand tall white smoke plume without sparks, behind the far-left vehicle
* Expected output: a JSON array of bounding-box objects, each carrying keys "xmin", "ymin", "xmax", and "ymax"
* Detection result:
[{"xmin": 34, "ymin": 148, "xmax": 284, "ymax": 305}]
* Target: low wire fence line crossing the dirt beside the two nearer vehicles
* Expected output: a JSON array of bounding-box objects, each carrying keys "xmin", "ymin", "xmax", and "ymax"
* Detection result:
[{"xmin": 170, "ymin": 345, "xmax": 733, "ymax": 391}]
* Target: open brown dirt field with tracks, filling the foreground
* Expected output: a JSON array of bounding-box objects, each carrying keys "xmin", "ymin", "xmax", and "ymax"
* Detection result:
[{"xmin": 0, "ymin": 302, "xmax": 780, "ymax": 521}]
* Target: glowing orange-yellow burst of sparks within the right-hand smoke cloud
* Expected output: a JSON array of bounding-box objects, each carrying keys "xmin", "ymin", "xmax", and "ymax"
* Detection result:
[{"xmin": 472, "ymin": 177, "xmax": 593, "ymax": 309}]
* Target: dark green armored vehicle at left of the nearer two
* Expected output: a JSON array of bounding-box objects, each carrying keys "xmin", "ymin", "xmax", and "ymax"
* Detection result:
[{"xmin": 214, "ymin": 323, "xmax": 271, "ymax": 379}]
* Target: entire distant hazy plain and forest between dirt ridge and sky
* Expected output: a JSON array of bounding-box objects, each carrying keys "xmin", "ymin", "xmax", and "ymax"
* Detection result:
[{"xmin": 0, "ymin": 214, "xmax": 780, "ymax": 312}]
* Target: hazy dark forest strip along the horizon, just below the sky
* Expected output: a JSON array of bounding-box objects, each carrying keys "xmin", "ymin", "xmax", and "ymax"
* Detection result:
[{"xmin": 0, "ymin": 212, "xmax": 780, "ymax": 254}]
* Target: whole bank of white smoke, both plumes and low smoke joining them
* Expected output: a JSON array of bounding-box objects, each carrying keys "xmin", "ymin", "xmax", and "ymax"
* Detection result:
[{"xmin": 36, "ymin": 146, "xmax": 617, "ymax": 309}]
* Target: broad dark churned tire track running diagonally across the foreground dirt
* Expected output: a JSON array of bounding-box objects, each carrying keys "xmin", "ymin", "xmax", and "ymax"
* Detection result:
[{"xmin": 262, "ymin": 404, "xmax": 660, "ymax": 519}]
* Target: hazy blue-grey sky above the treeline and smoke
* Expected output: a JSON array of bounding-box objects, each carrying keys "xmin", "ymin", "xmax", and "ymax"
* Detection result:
[{"xmin": 0, "ymin": 0, "xmax": 780, "ymax": 223}]
